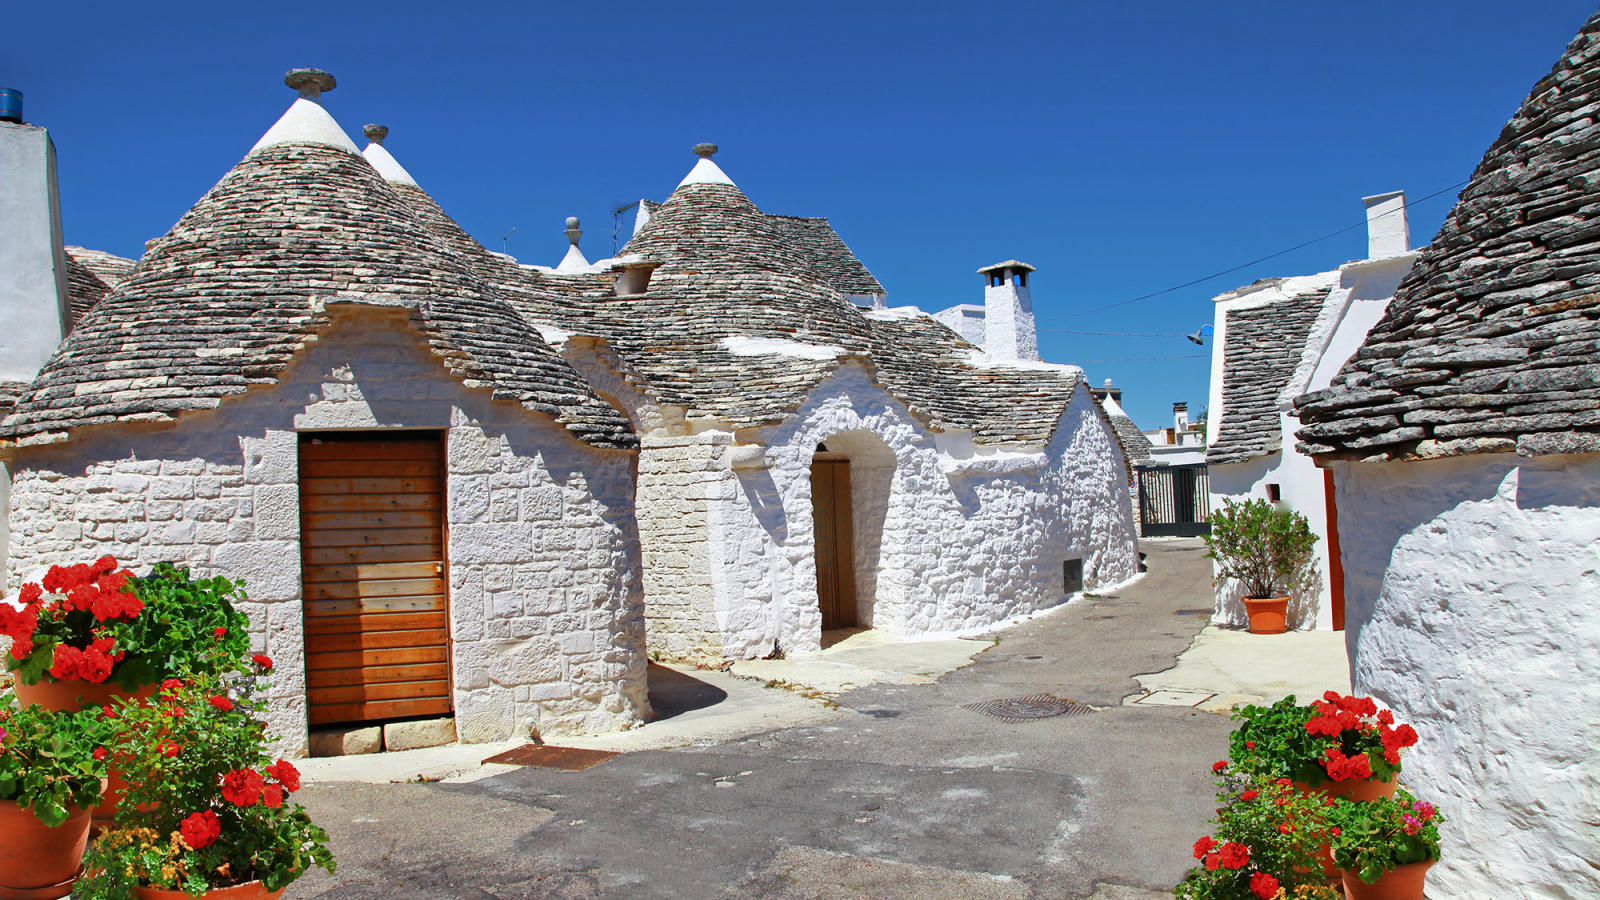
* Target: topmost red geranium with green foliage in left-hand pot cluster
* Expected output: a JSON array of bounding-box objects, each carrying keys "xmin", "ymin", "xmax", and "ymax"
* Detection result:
[{"xmin": 0, "ymin": 556, "xmax": 250, "ymax": 709}]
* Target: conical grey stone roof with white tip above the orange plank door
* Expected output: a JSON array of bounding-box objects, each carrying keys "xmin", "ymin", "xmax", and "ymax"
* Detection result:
[{"xmin": 0, "ymin": 99, "xmax": 637, "ymax": 448}]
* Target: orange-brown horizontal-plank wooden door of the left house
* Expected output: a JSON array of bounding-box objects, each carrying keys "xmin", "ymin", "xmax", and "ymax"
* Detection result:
[{"xmin": 299, "ymin": 431, "xmax": 450, "ymax": 725}]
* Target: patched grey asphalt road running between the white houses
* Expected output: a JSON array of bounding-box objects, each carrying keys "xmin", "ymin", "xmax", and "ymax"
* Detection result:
[{"xmin": 290, "ymin": 541, "xmax": 1229, "ymax": 900}]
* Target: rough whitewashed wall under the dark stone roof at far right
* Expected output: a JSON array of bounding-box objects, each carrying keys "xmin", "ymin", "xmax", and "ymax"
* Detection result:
[{"xmin": 1336, "ymin": 455, "xmax": 1600, "ymax": 900}]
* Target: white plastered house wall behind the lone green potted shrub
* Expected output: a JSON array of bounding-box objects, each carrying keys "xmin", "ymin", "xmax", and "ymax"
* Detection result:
[{"xmin": 1206, "ymin": 251, "xmax": 1418, "ymax": 631}]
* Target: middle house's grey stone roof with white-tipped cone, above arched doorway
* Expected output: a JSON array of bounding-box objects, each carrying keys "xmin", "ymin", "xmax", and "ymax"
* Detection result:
[{"xmin": 390, "ymin": 140, "xmax": 1082, "ymax": 445}]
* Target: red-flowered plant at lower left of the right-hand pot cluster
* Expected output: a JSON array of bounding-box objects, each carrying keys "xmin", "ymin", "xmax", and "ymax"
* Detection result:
[{"xmin": 1173, "ymin": 762, "xmax": 1336, "ymax": 900}]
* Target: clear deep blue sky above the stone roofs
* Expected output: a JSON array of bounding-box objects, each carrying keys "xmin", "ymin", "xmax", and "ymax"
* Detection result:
[{"xmin": 0, "ymin": 0, "xmax": 1594, "ymax": 428}]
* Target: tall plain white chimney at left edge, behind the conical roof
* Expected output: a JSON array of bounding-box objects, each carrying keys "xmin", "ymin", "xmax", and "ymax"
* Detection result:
[{"xmin": 0, "ymin": 91, "xmax": 72, "ymax": 381}]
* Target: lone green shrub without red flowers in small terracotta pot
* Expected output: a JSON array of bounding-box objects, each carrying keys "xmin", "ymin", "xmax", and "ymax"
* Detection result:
[{"xmin": 1205, "ymin": 498, "xmax": 1317, "ymax": 634}]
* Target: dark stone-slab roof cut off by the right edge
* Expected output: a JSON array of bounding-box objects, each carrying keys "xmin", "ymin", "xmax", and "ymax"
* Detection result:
[{"xmin": 1296, "ymin": 13, "xmax": 1600, "ymax": 460}]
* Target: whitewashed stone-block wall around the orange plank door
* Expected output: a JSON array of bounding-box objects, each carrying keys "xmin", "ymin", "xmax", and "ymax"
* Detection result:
[{"xmin": 8, "ymin": 309, "xmax": 648, "ymax": 753}]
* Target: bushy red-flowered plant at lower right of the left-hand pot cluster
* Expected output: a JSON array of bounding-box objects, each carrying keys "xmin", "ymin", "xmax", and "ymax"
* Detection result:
[{"xmin": 75, "ymin": 655, "xmax": 333, "ymax": 900}]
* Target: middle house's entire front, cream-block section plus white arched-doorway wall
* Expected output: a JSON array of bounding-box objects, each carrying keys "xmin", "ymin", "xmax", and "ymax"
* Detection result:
[{"xmin": 578, "ymin": 350, "xmax": 1138, "ymax": 658}]
